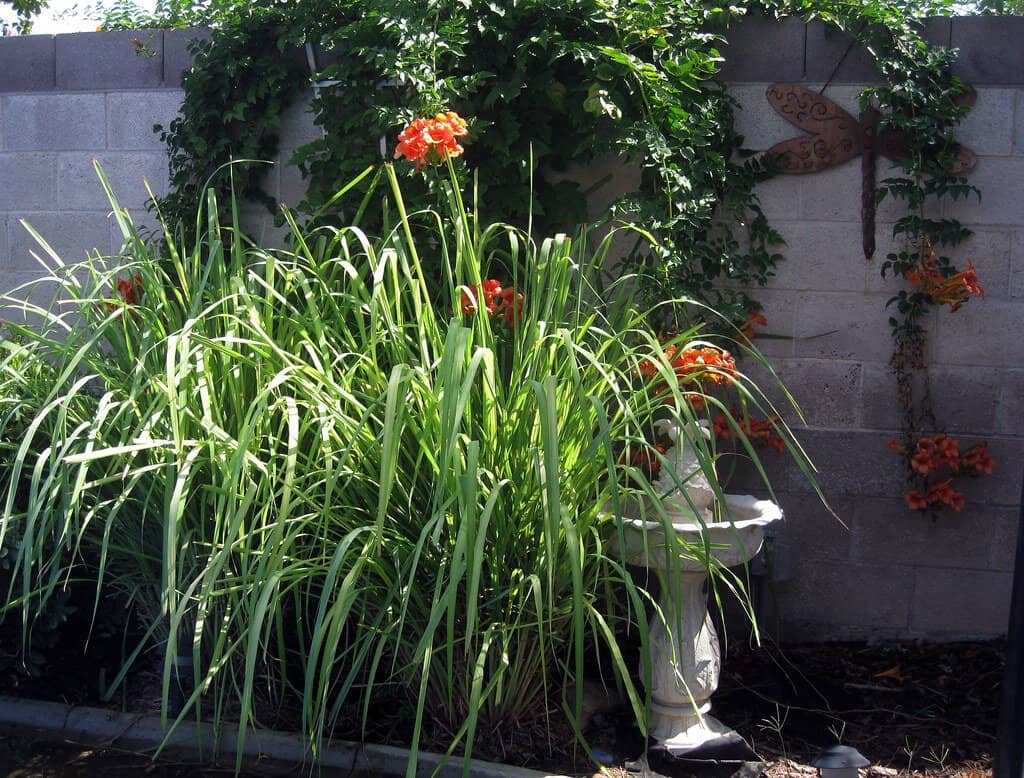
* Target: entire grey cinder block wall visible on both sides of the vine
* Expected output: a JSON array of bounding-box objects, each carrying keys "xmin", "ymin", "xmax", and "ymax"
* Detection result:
[{"xmin": 0, "ymin": 18, "xmax": 1024, "ymax": 641}]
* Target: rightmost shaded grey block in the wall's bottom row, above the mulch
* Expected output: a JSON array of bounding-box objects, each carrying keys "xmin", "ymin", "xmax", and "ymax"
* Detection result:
[{"xmin": 909, "ymin": 567, "xmax": 1013, "ymax": 640}]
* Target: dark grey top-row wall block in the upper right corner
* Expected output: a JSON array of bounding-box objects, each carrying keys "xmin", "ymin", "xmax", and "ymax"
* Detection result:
[{"xmin": 950, "ymin": 16, "xmax": 1024, "ymax": 86}]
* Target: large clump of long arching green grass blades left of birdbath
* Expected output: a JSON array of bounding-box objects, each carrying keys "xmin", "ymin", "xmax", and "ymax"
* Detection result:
[{"xmin": 0, "ymin": 162, "xmax": 808, "ymax": 775}]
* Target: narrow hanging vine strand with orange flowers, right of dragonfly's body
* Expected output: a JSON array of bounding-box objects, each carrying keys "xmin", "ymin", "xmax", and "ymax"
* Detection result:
[{"xmin": 862, "ymin": 39, "xmax": 995, "ymax": 515}]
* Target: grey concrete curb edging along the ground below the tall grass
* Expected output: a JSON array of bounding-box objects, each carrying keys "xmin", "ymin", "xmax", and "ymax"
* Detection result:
[{"xmin": 0, "ymin": 696, "xmax": 567, "ymax": 778}]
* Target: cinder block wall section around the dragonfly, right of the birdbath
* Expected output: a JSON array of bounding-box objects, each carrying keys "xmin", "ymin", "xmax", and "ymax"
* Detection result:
[{"xmin": 724, "ymin": 17, "xmax": 1024, "ymax": 641}]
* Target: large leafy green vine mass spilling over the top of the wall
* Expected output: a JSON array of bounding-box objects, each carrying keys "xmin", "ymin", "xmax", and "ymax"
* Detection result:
[{"xmin": 96, "ymin": 0, "xmax": 983, "ymax": 331}]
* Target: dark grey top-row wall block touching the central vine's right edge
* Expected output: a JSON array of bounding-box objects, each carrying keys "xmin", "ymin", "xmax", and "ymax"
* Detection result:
[{"xmin": 719, "ymin": 17, "xmax": 804, "ymax": 82}]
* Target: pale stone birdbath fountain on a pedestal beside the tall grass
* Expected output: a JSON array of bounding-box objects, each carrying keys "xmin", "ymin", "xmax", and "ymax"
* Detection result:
[{"xmin": 624, "ymin": 423, "xmax": 782, "ymax": 759}]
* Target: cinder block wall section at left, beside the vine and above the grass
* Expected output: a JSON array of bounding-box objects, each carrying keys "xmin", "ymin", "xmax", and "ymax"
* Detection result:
[{"xmin": 0, "ymin": 31, "xmax": 190, "ymax": 300}]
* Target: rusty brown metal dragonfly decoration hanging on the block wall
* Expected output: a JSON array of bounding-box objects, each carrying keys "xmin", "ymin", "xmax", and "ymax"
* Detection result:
[{"xmin": 767, "ymin": 84, "xmax": 977, "ymax": 259}]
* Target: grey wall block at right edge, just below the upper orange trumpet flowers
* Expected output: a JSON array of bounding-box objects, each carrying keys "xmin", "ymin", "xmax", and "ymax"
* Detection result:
[{"xmin": 931, "ymin": 299, "xmax": 1024, "ymax": 370}]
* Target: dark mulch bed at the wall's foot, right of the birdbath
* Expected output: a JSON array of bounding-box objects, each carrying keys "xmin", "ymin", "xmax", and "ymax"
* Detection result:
[{"xmin": 715, "ymin": 641, "xmax": 1007, "ymax": 774}]
